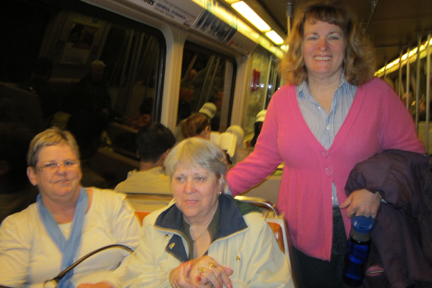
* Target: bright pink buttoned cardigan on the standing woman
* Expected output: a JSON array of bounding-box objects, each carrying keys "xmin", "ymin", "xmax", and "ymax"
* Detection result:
[{"xmin": 227, "ymin": 78, "xmax": 424, "ymax": 260}]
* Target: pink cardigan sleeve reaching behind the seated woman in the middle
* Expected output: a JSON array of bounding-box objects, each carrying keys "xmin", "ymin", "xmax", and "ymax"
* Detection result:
[{"xmin": 227, "ymin": 94, "xmax": 283, "ymax": 196}]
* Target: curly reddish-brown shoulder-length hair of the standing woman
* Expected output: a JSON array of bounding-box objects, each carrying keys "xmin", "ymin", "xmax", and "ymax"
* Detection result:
[{"xmin": 279, "ymin": 0, "xmax": 375, "ymax": 86}]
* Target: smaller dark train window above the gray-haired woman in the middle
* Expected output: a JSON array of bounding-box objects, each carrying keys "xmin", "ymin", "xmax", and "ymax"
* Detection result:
[{"xmin": 177, "ymin": 42, "xmax": 236, "ymax": 131}]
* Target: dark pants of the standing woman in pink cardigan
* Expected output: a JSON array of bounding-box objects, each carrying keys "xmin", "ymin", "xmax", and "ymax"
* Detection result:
[{"xmin": 294, "ymin": 207, "xmax": 350, "ymax": 288}]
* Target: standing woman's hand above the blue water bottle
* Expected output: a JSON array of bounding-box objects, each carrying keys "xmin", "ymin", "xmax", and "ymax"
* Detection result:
[{"xmin": 339, "ymin": 189, "xmax": 382, "ymax": 218}]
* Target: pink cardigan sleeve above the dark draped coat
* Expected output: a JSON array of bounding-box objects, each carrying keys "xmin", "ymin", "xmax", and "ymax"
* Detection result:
[{"xmin": 379, "ymin": 83, "xmax": 425, "ymax": 154}]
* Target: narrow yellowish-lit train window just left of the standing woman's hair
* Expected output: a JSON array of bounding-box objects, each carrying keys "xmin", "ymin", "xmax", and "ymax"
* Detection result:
[{"xmin": 243, "ymin": 49, "xmax": 280, "ymax": 138}]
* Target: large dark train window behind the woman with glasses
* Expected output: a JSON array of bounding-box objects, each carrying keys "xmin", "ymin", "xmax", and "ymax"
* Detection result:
[{"xmin": 0, "ymin": 0, "xmax": 166, "ymax": 158}]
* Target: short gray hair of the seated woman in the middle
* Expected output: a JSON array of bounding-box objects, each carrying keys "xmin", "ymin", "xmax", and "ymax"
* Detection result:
[{"xmin": 165, "ymin": 137, "xmax": 228, "ymax": 186}]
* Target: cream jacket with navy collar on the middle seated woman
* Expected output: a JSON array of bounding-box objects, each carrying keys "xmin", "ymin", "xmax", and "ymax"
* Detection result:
[{"xmin": 122, "ymin": 195, "xmax": 294, "ymax": 288}]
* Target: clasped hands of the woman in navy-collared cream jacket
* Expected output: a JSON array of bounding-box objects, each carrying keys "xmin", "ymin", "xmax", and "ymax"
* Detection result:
[{"xmin": 186, "ymin": 255, "xmax": 233, "ymax": 288}]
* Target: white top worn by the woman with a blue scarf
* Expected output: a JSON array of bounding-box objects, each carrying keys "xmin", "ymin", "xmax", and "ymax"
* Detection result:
[{"xmin": 0, "ymin": 188, "xmax": 140, "ymax": 288}]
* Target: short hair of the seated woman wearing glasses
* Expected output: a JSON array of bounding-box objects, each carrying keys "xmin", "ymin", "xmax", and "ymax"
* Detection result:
[{"xmin": 27, "ymin": 127, "xmax": 80, "ymax": 167}]
